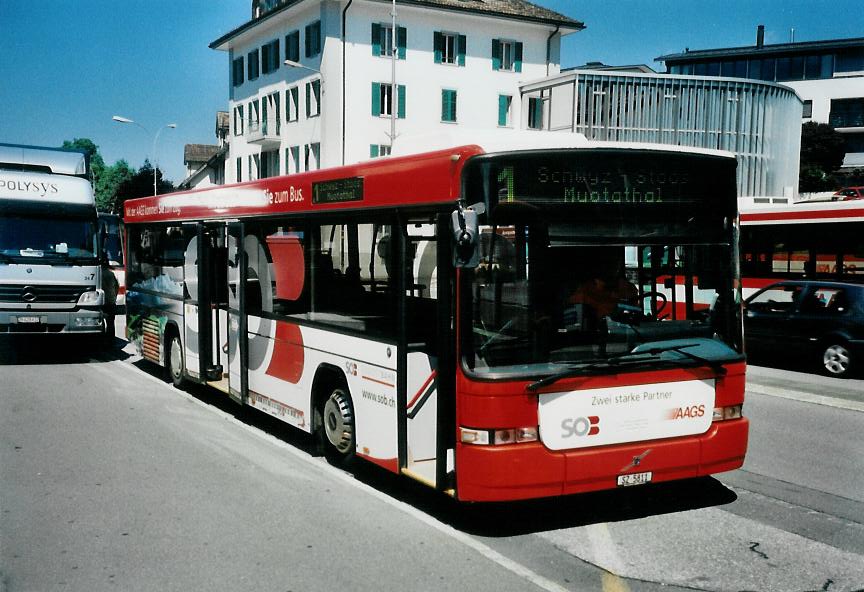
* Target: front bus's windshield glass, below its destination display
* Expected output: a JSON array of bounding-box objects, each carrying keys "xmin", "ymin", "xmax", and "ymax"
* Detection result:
[{"xmin": 468, "ymin": 225, "xmax": 741, "ymax": 373}]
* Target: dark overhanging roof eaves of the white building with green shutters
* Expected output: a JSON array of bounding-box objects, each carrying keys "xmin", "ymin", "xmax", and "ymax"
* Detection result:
[{"xmin": 210, "ymin": 0, "xmax": 585, "ymax": 49}]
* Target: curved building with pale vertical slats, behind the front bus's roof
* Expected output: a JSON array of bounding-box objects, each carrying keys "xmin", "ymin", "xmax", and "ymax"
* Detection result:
[{"xmin": 521, "ymin": 70, "xmax": 802, "ymax": 205}]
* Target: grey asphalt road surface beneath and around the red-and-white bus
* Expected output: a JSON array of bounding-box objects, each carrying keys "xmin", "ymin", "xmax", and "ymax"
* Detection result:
[{"xmin": 0, "ymin": 328, "xmax": 864, "ymax": 592}]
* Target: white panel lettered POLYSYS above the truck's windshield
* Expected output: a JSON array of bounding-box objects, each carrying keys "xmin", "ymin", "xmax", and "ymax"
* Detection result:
[{"xmin": 0, "ymin": 170, "xmax": 96, "ymax": 208}]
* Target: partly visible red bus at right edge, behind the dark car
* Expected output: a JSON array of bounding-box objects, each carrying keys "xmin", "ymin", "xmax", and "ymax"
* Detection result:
[{"xmin": 741, "ymin": 200, "xmax": 864, "ymax": 296}]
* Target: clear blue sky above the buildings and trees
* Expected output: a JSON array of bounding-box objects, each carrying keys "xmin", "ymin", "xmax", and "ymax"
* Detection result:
[{"xmin": 0, "ymin": 0, "xmax": 864, "ymax": 182}]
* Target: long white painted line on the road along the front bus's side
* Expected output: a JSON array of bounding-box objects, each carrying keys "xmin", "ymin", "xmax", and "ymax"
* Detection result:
[{"xmin": 110, "ymin": 356, "xmax": 576, "ymax": 592}]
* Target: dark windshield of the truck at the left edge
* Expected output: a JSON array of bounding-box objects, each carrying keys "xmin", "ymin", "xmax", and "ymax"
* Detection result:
[{"xmin": 0, "ymin": 213, "xmax": 97, "ymax": 264}]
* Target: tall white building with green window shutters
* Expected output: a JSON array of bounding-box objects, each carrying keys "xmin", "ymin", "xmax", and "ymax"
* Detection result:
[{"xmin": 210, "ymin": 0, "xmax": 584, "ymax": 183}]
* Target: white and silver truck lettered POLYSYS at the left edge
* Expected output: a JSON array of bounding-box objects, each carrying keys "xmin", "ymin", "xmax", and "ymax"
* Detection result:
[{"xmin": 0, "ymin": 144, "xmax": 117, "ymax": 337}]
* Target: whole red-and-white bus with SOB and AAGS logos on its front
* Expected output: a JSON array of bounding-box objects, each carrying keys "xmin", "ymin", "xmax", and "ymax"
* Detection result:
[{"xmin": 125, "ymin": 134, "xmax": 748, "ymax": 501}]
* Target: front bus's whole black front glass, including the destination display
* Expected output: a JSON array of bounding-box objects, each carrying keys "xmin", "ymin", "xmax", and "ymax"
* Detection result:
[{"xmin": 462, "ymin": 153, "xmax": 742, "ymax": 377}]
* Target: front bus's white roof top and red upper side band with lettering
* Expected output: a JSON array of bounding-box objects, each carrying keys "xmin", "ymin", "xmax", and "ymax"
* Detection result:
[{"xmin": 124, "ymin": 138, "xmax": 734, "ymax": 223}]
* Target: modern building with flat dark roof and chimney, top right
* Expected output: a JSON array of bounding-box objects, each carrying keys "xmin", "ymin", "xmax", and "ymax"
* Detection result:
[{"xmin": 657, "ymin": 25, "xmax": 864, "ymax": 170}]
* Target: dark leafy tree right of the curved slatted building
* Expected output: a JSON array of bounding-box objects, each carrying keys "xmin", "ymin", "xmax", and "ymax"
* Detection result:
[{"xmin": 798, "ymin": 121, "xmax": 846, "ymax": 192}]
